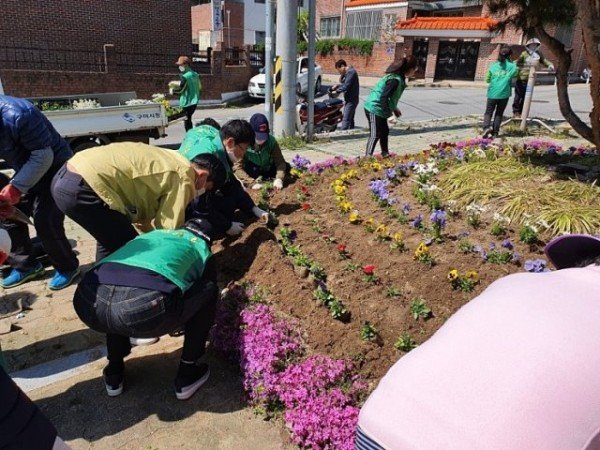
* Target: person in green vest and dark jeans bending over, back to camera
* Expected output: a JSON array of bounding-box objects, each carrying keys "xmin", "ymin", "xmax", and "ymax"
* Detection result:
[{"xmin": 73, "ymin": 219, "xmax": 218, "ymax": 400}]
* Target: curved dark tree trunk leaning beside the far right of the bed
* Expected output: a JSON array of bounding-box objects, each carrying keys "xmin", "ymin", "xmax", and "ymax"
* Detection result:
[{"xmin": 535, "ymin": 24, "xmax": 600, "ymax": 146}]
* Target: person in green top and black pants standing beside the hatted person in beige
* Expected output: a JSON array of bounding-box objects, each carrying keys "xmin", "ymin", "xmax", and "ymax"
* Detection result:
[{"xmin": 483, "ymin": 46, "xmax": 519, "ymax": 138}]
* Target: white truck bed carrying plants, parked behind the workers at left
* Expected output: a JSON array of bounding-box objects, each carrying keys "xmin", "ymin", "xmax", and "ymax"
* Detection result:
[{"xmin": 0, "ymin": 80, "xmax": 169, "ymax": 152}]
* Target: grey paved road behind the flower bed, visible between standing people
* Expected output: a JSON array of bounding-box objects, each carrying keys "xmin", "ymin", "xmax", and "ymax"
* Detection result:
[{"xmin": 153, "ymin": 84, "xmax": 592, "ymax": 145}]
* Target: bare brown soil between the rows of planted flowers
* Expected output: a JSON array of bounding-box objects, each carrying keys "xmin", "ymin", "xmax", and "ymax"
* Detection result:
[{"xmin": 215, "ymin": 163, "xmax": 543, "ymax": 381}]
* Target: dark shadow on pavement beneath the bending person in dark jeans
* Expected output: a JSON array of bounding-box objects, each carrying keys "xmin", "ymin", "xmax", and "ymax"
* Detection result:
[{"xmin": 36, "ymin": 351, "xmax": 244, "ymax": 444}]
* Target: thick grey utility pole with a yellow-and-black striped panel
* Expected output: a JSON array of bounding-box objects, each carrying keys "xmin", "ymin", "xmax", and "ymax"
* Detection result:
[{"xmin": 275, "ymin": 0, "xmax": 298, "ymax": 136}]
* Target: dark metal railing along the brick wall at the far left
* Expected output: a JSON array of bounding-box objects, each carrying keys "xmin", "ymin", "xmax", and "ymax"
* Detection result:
[{"xmin": 0, "ymin": 45, "xmax": 106, "ymax": 72}]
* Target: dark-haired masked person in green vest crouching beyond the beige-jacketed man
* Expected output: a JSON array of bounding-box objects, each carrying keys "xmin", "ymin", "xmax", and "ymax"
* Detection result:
[{"xmin": 179, "ymin": 119, "xmax": 269, "ymax": 238}]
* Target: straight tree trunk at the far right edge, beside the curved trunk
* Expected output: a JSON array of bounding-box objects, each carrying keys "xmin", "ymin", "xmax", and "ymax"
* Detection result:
[{"xmin": 576, "ymin": 0, "xmax": 600, "ymax": 149}]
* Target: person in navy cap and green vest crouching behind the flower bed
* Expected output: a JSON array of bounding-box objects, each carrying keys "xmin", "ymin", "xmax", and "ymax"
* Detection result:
[{"xmin": 241, "ymin": 114, "xmax": 290, "ymax": 190}]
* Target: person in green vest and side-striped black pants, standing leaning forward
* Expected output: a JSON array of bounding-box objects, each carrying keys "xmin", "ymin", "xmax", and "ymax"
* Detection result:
[{"xmin": 365, "ymin": 55, "xmax": 417, "ymax": 157}]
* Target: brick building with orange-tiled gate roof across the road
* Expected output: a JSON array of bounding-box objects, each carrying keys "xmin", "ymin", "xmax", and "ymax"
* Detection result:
[{"xmin": 317, "ymin": 0, "xmax": 587, "ymax": 81}]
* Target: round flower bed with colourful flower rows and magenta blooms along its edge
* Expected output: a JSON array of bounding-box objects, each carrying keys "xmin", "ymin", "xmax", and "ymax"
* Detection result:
[{"xmin": 214, "ymin": 140, "xmax": 600, "ymax": 448}]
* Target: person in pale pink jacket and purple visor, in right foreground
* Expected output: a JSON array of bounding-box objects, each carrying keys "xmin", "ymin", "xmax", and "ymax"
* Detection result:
[{"xmin": 356, "ymin": 235, "xmax": 600, "ymax": 450}]
